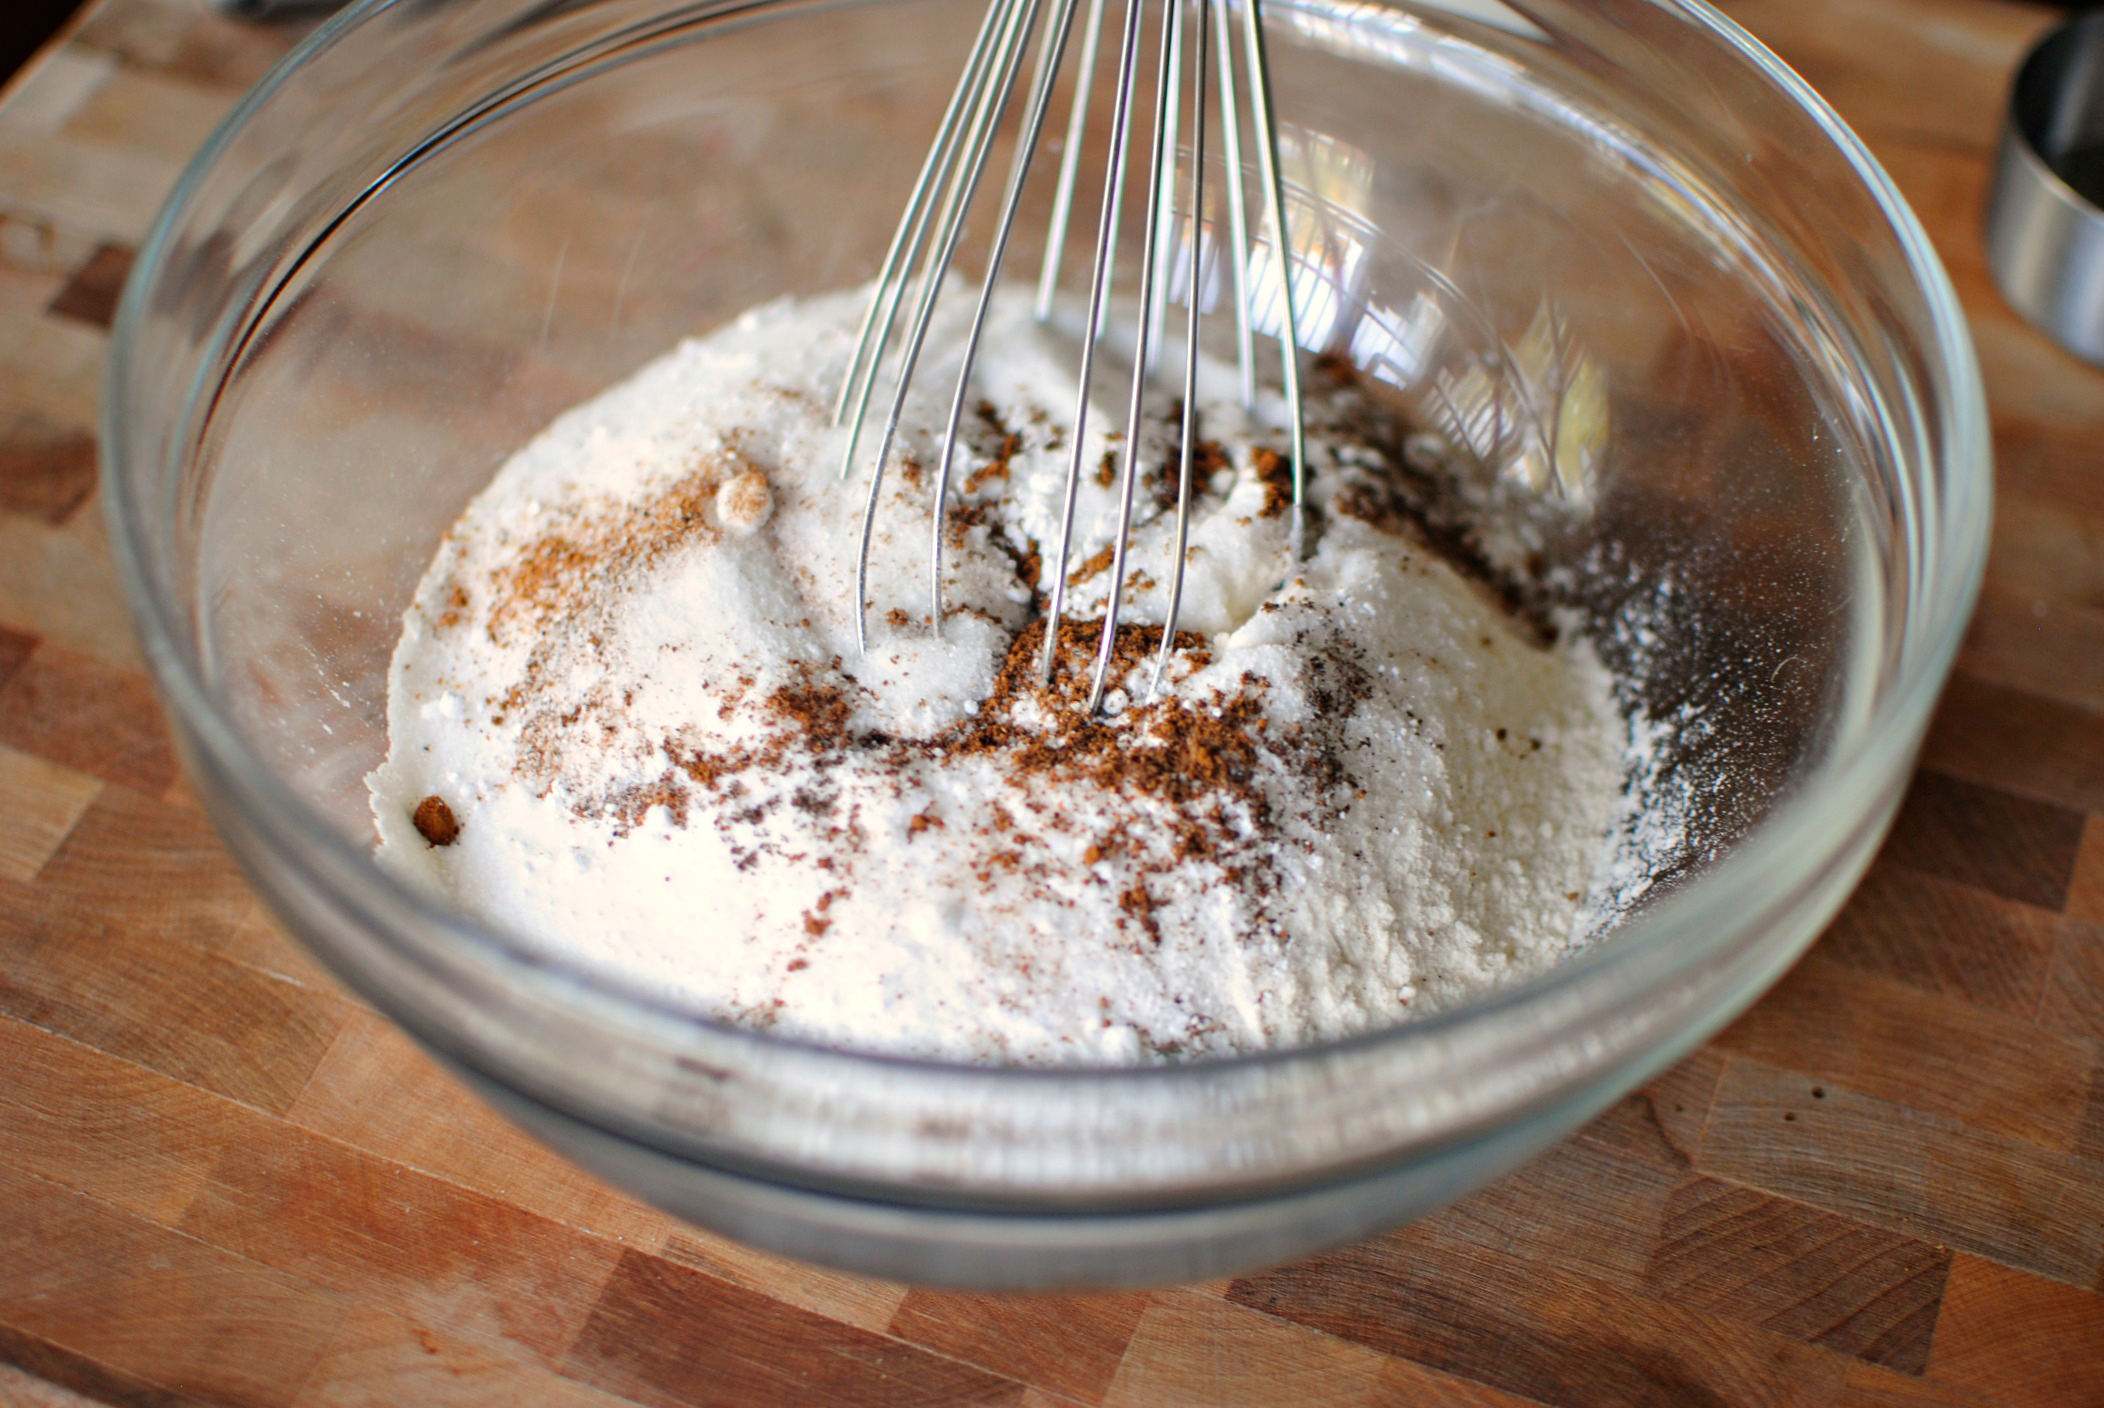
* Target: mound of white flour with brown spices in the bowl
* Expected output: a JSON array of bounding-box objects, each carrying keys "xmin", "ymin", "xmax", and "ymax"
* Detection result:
[{"xmin": 370, "ymin": 293, "xmax": 1628, "ymax": 1063}]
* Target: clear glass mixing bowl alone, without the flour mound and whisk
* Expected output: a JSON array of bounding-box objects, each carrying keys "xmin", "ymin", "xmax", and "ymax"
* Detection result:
[{"xmin": 103, "ymin": 0, "xmax": 1988, "ymax": 1286}]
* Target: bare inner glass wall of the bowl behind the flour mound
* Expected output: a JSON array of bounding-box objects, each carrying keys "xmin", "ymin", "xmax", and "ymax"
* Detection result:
[{"xmin": 149, "ymin": 0, "xmax": 1931, "ymax": 1043}]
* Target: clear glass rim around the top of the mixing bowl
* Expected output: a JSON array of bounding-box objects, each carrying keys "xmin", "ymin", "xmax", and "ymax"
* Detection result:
[{"xmin": 99, "ymin": 0, "xmax": 1992, "ymax": 1090}]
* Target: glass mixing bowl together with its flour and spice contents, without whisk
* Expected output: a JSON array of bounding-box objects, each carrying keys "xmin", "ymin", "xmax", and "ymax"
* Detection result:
[{"xmin": 105, "ymin": 0, "xmax": 1986, "ymax": 1286}]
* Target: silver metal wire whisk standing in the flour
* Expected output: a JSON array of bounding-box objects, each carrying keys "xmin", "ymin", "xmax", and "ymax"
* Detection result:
[{"xmin": 835, "ymin": 0, "xmax": 1307, "ymax": 713}]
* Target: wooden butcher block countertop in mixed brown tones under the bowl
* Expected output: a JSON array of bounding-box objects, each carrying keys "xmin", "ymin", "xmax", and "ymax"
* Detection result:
[{"xmin": 0, "ymin": 0, "xmax": 2104, "ymax": 1408}]
